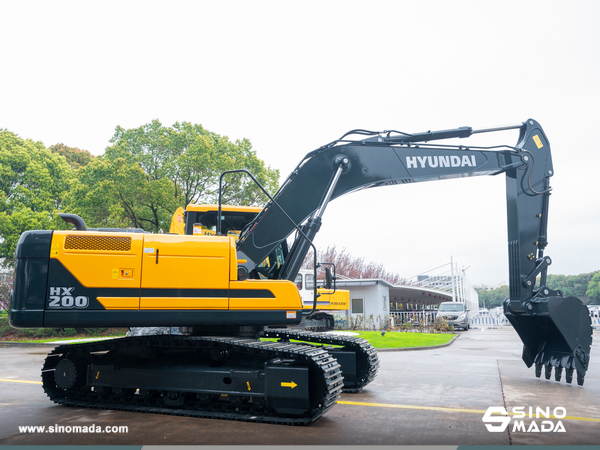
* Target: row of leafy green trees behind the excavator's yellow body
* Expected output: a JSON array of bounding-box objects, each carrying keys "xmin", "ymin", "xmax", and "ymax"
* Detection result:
[{"xmin": 0, "ymin": 120, "xmax": 279, "ymax": 267}]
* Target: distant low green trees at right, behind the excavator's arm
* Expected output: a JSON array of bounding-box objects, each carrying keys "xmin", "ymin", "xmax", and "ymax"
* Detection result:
[{"xmin": 477, "ymin": 271, "xmax": 600, "ymax": 308}]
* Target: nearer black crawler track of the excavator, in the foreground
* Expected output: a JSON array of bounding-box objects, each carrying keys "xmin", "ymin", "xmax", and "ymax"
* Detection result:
[{"xmin": 42, "ymin": 336, "xmax": 343, "ymax": 425}]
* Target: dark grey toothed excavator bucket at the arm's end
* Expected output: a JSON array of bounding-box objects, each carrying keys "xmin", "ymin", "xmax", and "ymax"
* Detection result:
[{"xmin": 504, "ymin": 296, "xmax": 592, "ymax": 386}]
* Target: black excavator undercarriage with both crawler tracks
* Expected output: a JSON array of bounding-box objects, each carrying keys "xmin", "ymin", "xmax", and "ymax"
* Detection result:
[{"xmin": 42, "ymin": 330, "xmax": 379, "ymax": 425}]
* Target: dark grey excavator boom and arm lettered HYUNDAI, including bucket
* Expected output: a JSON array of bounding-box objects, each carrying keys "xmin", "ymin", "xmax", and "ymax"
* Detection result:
[{"xmin": 237, "ymin": 119, "xmax": 592, "ymax": 384}]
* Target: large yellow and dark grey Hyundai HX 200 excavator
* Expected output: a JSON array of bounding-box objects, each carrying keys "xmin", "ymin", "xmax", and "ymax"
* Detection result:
[{"xmin": 10, "ymin": 119, "xmax": 592, "ymax": 424}]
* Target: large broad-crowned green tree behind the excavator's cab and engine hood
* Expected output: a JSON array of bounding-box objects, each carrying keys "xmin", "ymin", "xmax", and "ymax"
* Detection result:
[{"xmin": 69, "ymin": 120, "xmax": 279, "ymax": 231}]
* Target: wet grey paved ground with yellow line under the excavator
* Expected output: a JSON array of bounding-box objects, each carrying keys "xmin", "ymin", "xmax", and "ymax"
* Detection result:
[{"xmin": 0, "ymin": 327, "xmax": 600, "ymax": 445}]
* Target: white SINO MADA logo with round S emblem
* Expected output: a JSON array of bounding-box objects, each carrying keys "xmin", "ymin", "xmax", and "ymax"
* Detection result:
[{"xmin": 481, "ymin": 406, "xmax": 567, "ymax": 433}]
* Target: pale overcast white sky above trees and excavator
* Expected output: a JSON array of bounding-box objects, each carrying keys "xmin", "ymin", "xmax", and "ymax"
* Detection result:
[{"xmin": 0, "ymin": 0, "xmax": 600, "ymax": 285}]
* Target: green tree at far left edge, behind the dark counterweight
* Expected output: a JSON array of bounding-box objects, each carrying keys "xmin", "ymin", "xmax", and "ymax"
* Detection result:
[{"xmin": 0, "ymin": 130, "xmax": 73, "ymax": 266}]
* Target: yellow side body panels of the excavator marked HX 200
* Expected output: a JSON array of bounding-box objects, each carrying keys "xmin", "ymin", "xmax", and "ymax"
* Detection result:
[{"xmin": 32, "ymin": 231, "xmax": 302, "ymax": 326}]
